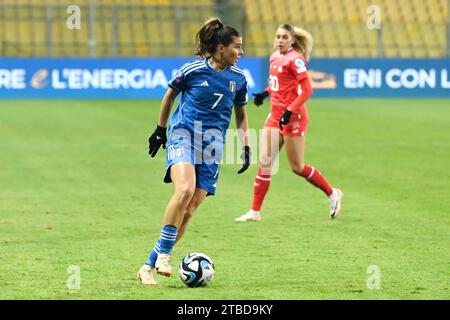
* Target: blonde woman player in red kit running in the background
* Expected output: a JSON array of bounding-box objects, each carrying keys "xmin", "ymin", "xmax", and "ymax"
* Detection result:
[{"xmin": 235, "ymin": 24, "xmax": 343, "ymax": 222}]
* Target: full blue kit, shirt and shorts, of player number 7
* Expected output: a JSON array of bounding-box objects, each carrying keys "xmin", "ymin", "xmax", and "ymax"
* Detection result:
[{"xmin": 164, "ymin": 59, "xmax": 248, "ymax": 195}]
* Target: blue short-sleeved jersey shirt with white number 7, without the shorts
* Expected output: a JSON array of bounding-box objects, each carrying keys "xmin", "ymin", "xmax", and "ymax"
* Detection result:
[{"xmin": 169, "ymin": 59, "xmax": 248, "ymax": 135}]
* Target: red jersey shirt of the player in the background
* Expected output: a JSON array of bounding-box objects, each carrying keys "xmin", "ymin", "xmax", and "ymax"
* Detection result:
[{"xmin": 266, "ymin": 48, "xmax": 308, "ymax": 119}]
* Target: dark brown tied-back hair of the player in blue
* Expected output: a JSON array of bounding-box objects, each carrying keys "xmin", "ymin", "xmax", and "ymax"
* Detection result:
[{"xmin": 195, "ymin": 17, "xmax": 241, "ymax": 58}]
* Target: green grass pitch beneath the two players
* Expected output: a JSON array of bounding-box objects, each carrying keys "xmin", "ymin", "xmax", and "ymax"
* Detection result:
[{"xmin": 0, "ymin": 99, "xmax": 450, "ymax": 299}]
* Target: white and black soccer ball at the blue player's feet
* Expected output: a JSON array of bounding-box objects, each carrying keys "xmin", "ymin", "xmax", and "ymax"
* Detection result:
[{"xmin": 178, "ymin": 252, "xmax": 216, "ymax": 288}]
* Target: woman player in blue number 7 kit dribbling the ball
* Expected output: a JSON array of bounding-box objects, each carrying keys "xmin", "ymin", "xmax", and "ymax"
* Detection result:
[{"xmin": 137, "ymin": 18, "xmax": 250, "ymax": 285}]
